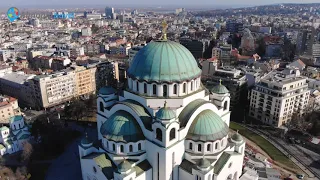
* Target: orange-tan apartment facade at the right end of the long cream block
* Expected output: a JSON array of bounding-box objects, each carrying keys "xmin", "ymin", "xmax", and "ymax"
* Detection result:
[{"xmin": 74, "ymin": 66, "xmax": 97, "ymax": 96}]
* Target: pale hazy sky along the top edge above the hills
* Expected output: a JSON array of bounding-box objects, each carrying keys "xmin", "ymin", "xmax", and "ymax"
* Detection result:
[{"xmin": 0, "ymin": 0, "xmax": 320, "ymax": 8}]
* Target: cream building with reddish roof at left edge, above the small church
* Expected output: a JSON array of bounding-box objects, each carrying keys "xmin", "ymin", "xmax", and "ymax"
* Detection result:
[{"xmin": 0, "ymin": 96, "xmax": 21, "ymax": 124}]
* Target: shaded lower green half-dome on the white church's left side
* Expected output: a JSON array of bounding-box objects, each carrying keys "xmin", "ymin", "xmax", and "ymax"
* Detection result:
[{"xmin": 100, "ymin": 110, "xmax": 145, "ymax": 142}]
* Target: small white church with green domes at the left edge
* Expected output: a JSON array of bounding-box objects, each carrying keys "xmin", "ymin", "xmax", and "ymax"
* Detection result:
[{"xmin": 0, "ymin": 116, "xmax": 31, "ymax": 156}]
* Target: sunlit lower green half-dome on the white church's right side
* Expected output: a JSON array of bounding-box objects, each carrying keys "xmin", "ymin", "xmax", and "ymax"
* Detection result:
[{"xmin": 187, "ymin": 110, "xmax": 229, "ymax": 142}]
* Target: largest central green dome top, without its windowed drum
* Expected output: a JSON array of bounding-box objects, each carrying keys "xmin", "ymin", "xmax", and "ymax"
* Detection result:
[{"xmin": 128, "ymin": 41, "xmax": 201, "ymax": 82}]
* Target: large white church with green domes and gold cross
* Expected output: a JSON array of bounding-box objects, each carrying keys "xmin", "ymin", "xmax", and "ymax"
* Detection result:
[{"xmin": 79, "ymin": 40, "xmax": 245, "ymax": 180}]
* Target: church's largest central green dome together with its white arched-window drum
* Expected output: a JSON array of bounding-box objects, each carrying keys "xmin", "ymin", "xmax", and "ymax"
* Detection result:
[{"xmin": 128, "ymin": 41, "xmax": 201, "ymax": 97}]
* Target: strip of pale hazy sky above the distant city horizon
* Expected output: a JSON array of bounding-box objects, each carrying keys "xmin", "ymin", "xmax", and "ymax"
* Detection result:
[{"xmin": 0, "ymin": 0, "xmax": 320, "ymax": 8}]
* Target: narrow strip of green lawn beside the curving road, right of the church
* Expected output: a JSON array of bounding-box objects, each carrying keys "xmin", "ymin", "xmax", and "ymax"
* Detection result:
[{"xmin": 230, "ymin": 122, "xmax": 299, "ymax": 169}]
